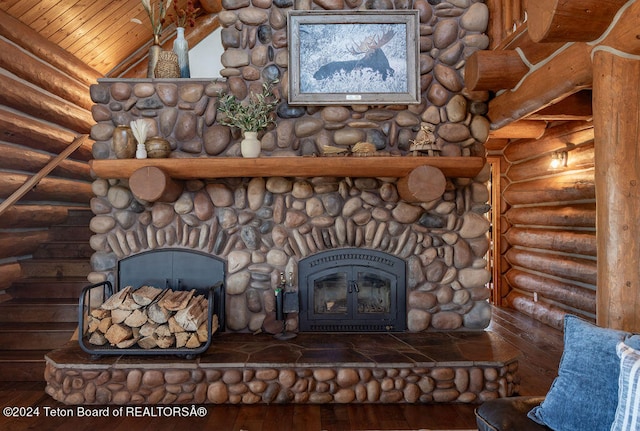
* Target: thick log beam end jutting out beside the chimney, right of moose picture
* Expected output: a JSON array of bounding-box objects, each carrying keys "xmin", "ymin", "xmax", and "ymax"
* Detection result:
[{"xmin": 464, "ymin": 51, "xmax": 529, "ymax": 91}]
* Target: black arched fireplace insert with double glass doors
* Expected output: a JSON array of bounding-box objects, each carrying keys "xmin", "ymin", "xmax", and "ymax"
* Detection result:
[{"xmin": 298, "ymin": 249, "xmax": 406, "ymax": 332}]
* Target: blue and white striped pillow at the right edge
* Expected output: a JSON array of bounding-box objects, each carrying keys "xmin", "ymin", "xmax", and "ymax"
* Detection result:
[{"xmin": 611, "ymin": 343, "xmax": 640, "ymax": 431}]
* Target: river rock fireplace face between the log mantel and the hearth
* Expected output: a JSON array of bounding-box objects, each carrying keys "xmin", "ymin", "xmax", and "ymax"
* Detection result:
[{"xmin": 90, "ymin": 174, "xmax": 490, "ymax": 333}]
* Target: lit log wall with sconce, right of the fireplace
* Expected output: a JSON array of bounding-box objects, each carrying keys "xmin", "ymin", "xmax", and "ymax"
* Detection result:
[{"xmin": 498, "ymin": 122, "xmax": 597, "ymax": 328}]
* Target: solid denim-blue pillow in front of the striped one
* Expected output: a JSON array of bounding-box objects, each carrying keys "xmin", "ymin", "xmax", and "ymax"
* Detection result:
[{"xmin": 529, "ymin": 315, "xmax": 635, "ymax": 431}]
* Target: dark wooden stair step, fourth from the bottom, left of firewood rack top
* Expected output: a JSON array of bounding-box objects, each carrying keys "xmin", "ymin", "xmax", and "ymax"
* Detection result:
[{"xmin": 8, "ymin": 276, "xmax": 90, "ymax": 302}]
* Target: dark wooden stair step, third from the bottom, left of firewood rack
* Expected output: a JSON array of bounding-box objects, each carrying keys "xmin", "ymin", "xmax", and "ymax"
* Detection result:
[{"xmin": 0, "ymin": 298, "xmax": 78, "ymax": 325}]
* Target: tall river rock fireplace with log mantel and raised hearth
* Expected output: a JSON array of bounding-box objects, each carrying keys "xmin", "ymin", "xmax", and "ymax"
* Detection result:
[{"xmin": 45, "ymin": 0, "xmax": 518, "ymax": 404}]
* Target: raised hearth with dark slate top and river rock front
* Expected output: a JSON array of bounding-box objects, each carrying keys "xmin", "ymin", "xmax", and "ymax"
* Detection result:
[{"xmin": 45, "ymin": 331, "xmax": 520, "ymax": 404}]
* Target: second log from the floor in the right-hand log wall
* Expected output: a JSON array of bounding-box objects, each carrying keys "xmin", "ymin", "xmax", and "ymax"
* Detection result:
[{"xmin": 505, "ymin": 269, "xmax": 596, "ymax": 314}]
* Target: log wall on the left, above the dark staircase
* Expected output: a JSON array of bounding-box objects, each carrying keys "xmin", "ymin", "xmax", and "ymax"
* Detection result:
[{"xmin": 0, "ymin": 11, "xmax": 99, "ymax": 293}]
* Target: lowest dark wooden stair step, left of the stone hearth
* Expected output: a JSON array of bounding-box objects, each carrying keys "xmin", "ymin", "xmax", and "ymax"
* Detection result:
[{"xmin": 0, "ymin": 350, "xmax": 49, "ymax": 382}]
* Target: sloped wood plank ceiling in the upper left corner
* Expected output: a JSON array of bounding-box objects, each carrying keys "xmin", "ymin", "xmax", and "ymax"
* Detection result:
[{"xmin": 0, "ymin": 0, "xmax": 211, "ymax": 76}]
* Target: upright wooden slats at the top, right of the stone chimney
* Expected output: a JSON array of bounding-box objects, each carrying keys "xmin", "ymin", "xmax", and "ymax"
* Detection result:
[{"xmin": 486, "ymin": 0, "xmax": 527, "ymax": 48}]
